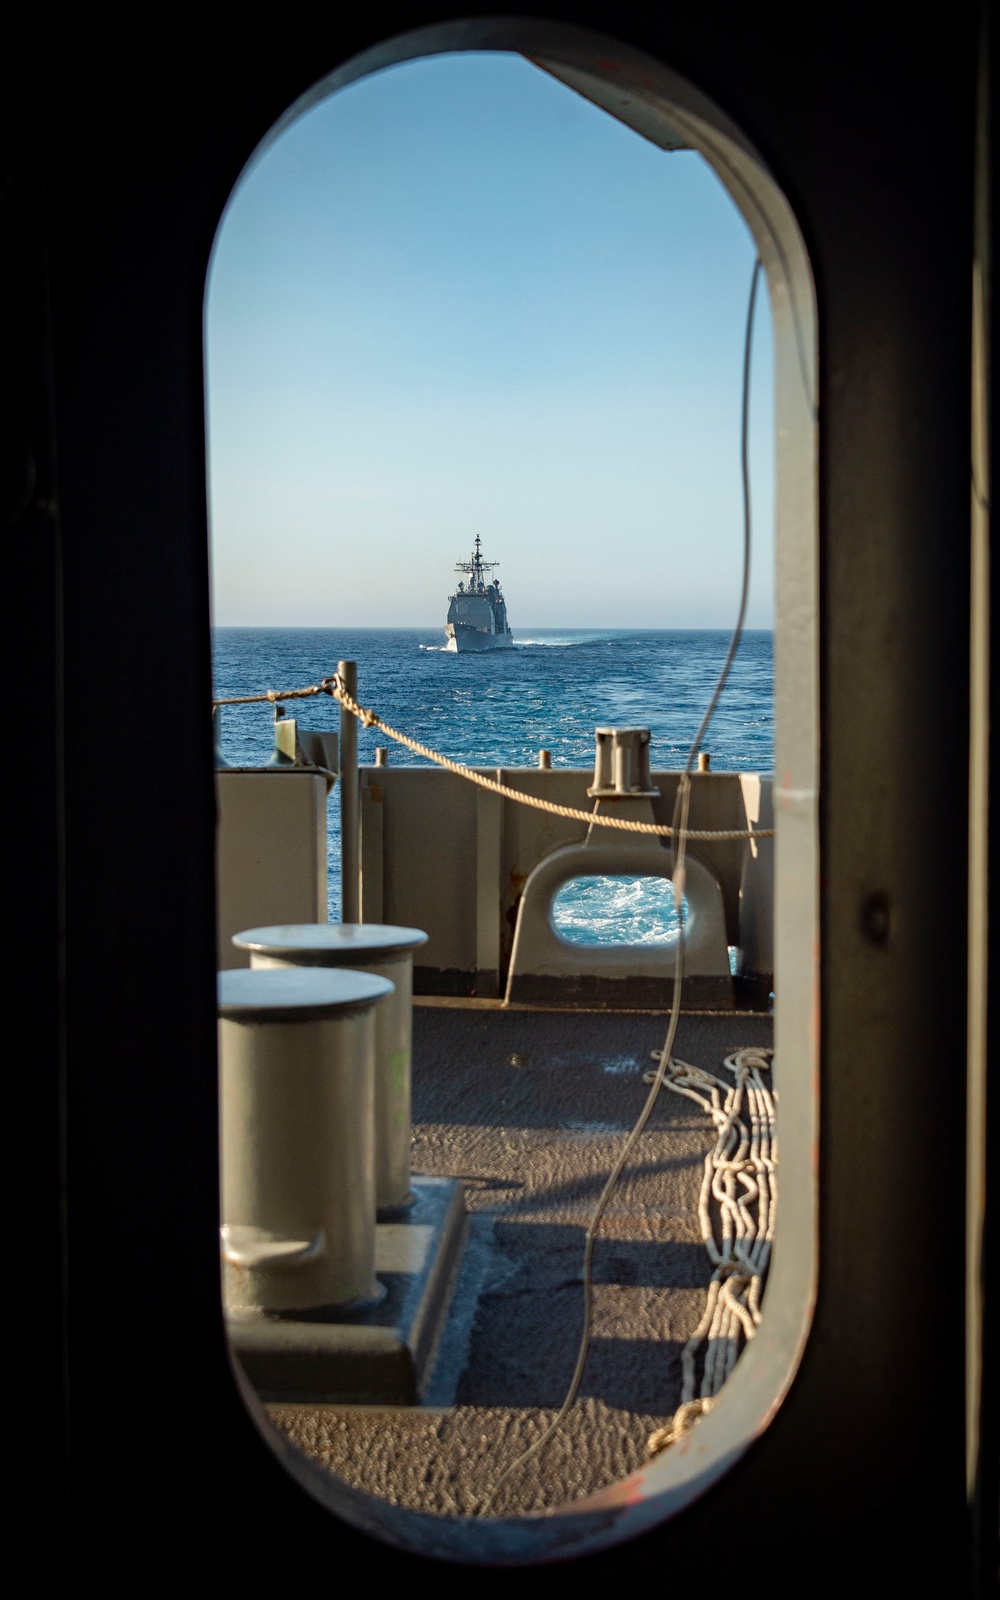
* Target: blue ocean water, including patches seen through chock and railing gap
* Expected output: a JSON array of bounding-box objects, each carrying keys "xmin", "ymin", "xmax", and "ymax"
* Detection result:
[{"xmin": 214, "ymin": 627, "xmax": 774, "ymax": 944}]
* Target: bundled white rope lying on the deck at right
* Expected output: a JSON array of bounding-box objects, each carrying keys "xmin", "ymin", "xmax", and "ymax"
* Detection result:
[{"xmin": 645, "ymin": 1046, "xmax": 778, "ymax": 1456}]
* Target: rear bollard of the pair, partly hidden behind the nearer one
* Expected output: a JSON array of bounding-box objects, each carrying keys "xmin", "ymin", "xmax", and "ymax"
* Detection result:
[{"xmin": 232, "ymin": 922, "xmax": 427, "ymax": 1216}]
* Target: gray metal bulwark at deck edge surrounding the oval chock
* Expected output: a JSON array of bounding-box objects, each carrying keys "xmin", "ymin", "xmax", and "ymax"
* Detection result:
[{"xmin": 360, "ymin": 762, "xmax": 774, "ymax": 1008}]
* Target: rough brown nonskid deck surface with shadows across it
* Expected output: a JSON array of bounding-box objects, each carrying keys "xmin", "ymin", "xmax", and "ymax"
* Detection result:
[{"xmin": 272, "ymin": 1002, "xmax": 771, "ymax": 1515}]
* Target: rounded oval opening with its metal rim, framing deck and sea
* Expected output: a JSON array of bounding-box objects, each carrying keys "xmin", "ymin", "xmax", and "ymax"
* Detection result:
[{"xmin": 206, "ymin": 19, "xmax": 818, "ymax": 1565}]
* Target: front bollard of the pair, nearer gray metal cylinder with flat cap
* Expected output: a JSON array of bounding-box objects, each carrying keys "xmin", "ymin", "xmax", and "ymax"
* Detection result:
[{"xmin": 219, "ymin": 968, "xmax": 392, "ymax": 1312}]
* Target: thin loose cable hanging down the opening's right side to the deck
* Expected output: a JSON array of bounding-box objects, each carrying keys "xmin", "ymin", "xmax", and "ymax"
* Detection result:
[{"xmin": 480, "ymin": 258, "xmax": 762, "ymax": 1517}]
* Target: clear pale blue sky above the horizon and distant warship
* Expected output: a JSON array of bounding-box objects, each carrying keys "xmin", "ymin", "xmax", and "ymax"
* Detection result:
[{"xmin": 206, "ymin": 54, "xmax": 773, "ymax": 632}]
